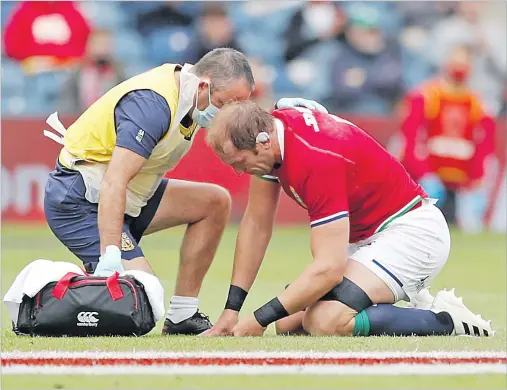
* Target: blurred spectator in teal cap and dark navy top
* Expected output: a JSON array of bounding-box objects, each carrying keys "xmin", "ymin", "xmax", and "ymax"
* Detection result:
[{"xmin": 327, "ymin": 5, "xmax": 402, "ymax": 114}]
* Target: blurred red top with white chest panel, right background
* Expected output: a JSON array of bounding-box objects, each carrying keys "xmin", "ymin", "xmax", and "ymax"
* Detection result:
[{"xmin": 401, "ymin": 80, "xmax": 495, "ymax": 189}]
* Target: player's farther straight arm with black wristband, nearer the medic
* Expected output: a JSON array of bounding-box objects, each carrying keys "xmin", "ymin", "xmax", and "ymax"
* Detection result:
[{"xmin": 203, "ymin": 176, "xmax": 280, "ymax": 336}]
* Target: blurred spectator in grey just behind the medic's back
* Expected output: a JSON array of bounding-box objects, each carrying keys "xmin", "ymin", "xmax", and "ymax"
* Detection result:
[{"xmin": 59, "ymin": 30, "xmax": 126, "ymax": 114}]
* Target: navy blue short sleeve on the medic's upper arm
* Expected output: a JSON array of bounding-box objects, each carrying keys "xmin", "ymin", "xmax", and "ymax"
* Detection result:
[{"xmin": 114, "ymin": 89, "xmax": 171, "ymax": 158}]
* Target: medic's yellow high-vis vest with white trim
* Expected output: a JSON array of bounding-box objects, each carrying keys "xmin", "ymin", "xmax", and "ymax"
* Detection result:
[{"xmin": 59, "ymin": 64, "xmax": 199, "ymax": 217}]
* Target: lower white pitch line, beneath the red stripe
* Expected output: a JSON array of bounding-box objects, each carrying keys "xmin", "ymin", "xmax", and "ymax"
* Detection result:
[{"xmin": 2, "ymin": 364, "xmax": 507, "ymax": 376}]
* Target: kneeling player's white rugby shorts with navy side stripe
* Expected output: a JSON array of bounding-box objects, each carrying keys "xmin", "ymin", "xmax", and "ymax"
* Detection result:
[{"xmin": 348, "ymin": 199, "xmax": 451, "ymax": 302}]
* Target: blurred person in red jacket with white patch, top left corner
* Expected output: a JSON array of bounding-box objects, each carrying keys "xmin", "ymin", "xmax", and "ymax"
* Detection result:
[{"xmin": 4, "ymin": 1, "xmax": 91, "ymax": 74}]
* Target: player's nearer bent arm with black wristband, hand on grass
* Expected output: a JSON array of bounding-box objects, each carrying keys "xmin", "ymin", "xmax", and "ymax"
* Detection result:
[{"xmin": 233, "ymin": 218, "xmax": 349, "ymax": 336}]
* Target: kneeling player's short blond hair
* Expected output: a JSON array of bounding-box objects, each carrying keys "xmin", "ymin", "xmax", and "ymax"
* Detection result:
[{"xmin": 208, "ymin": 100, "xmax": 275, "ymax": 151}]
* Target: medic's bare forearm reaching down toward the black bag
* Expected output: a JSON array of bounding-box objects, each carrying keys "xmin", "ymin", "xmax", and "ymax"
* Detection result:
[{"xmin": 98, "ymin": 146, "xmax": 145, "ymax": 253}]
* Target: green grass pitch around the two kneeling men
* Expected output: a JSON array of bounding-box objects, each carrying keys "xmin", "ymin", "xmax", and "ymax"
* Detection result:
[{"xmin": 1, "ymin": 225, "xmax": 507, "ymax": 389}]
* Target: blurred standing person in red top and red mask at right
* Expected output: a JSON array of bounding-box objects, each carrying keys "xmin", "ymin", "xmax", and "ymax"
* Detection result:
[{"xmin": 401, "ymin": 46, "xmax": 495, "ymax": 232}]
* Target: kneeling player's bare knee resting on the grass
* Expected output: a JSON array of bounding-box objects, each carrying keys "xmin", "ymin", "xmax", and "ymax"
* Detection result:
[{"xmin": 303, "ymin": 301, "xmax": 357, "ymax": 336}]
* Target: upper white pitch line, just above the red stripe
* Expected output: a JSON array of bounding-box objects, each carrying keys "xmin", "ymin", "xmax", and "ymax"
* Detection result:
[{"xmin": 2, "ymin": 351, "xmax": 507, "ymax": 360}]
